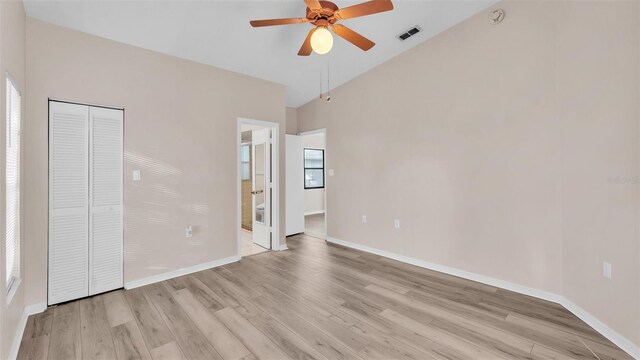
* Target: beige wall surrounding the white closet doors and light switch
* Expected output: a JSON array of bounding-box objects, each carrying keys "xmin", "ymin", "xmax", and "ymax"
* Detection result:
[{"xmin": 25, "ymin": 19, "xmax": 285, "ymax": 304}]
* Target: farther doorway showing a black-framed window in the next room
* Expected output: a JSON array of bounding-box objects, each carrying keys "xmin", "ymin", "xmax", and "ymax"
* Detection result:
[{"xmin": 300, "ymin": 129, "xmax": 327, "ymax": 240}]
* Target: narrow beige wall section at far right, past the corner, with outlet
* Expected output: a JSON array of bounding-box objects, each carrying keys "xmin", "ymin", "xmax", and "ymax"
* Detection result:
[{"xmin": 556, "ymin": 1, "xmax": 640, "ymax": 345}]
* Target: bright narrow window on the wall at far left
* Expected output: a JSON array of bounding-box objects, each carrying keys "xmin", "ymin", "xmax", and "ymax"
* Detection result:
[{"xmin": 5, "ymin": 76, "xmax": 21, "ymax": 301}]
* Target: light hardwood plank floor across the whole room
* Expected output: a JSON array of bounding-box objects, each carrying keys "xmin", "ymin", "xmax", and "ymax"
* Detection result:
[{"xmin": 18, "ymin": 235, "xmax": 630, "ymax": 360}]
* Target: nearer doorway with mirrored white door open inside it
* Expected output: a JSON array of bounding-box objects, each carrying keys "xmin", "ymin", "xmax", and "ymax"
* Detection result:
[{"xmin": 238, "ymin": 119, "xmax": 279, "ymax": 257}]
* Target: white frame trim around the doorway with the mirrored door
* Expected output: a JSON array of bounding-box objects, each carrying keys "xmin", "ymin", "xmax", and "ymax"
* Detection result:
[{"xmin": 236, "ymin": 117, "xmax": 287, "ymax": 258}]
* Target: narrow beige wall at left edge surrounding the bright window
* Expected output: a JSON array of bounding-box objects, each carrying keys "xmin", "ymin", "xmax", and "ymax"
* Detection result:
[{"xmin": 0, "ymin": 1, "xmax": 27, "ymax": 359}]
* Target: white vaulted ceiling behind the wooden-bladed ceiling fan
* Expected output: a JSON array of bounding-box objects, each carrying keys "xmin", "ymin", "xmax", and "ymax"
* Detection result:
[{"xmin": 24, "ymin": 0, "xmax": 496, "ymax": 107}]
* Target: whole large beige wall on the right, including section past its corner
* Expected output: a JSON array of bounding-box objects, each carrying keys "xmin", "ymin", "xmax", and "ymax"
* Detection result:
[{"xmin": 298, "ymin": 1, "xmax": 640, "ymax": 344}]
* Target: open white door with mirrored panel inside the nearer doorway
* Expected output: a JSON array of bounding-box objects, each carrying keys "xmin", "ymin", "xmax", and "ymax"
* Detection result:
[{"xmin": 251, "ymin": 129, "xmax": 271, "ymax": 249}]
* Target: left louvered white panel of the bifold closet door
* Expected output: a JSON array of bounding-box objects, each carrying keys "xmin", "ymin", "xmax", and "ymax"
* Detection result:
[{"xmin": 48, "ymin": 102, "xmax": 89, "ymax": 305}]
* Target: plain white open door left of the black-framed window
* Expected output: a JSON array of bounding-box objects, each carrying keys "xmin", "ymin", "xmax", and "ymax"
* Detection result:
[{"xmin": 285, "ymin": 135, "xmax": 304, "ymax": 236}]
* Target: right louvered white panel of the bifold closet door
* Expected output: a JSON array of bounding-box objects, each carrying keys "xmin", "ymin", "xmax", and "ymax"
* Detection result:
[{"xmin": 89, "ymin": 107, "xmax": 123, "ymax": 295}]
